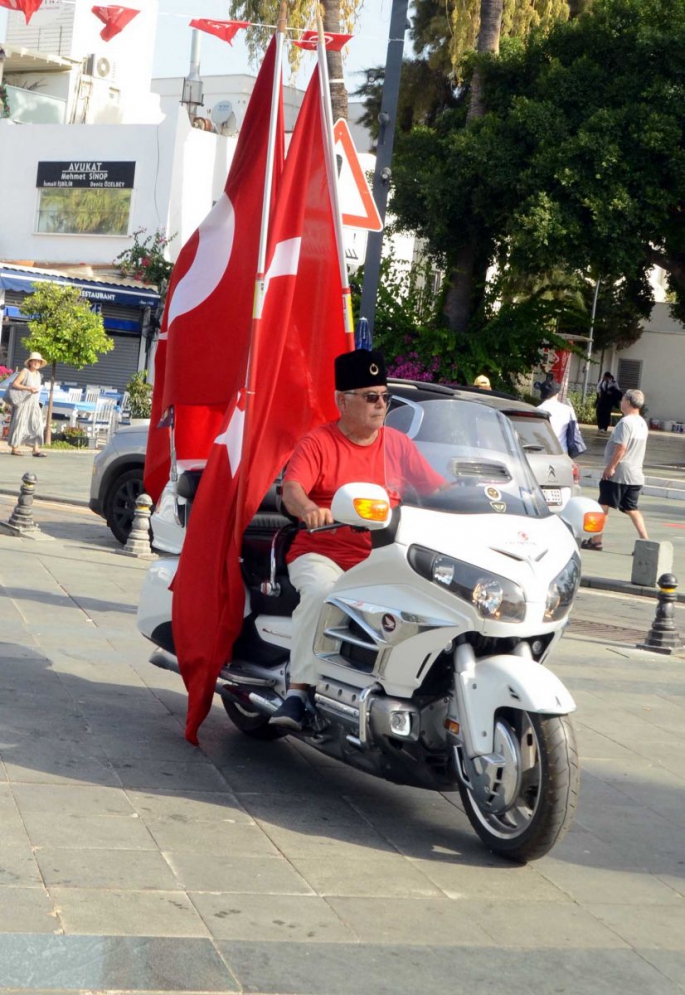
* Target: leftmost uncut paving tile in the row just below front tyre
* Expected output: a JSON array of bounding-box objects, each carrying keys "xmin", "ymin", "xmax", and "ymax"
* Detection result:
[{"xmin": 36, "ymin": 849, "xmax": 178, "ymax": 891}]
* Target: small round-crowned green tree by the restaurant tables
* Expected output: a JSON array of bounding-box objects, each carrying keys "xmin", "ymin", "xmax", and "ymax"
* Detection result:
[{"xmin": 21, "ymin": 281, "xmax": 114, "ymax": 444}]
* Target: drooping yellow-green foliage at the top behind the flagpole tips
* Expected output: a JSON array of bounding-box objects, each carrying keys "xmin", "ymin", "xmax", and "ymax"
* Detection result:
[{"xmin": 230, "ymin": 0, "xmax": 364, "ymax": 121}]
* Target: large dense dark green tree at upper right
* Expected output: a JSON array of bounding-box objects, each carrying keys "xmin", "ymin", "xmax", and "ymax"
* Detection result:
[{"xmin": 393, "ymin": 0, "xmax": 685, "ymax": 362}]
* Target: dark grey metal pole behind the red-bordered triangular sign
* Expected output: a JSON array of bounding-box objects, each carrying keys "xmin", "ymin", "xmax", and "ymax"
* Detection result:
[{"xmin": 360, "ymin": 0, "xmax": 409, "ymax": 335}]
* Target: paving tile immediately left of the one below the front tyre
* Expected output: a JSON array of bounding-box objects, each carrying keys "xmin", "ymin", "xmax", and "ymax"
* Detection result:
[{"xmin": 293, "ymin": 853, "xmax": 442, "ymax": 898}]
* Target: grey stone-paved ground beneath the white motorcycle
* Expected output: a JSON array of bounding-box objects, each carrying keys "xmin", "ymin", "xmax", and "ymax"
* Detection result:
[{"xmin": 0, "ymin": 502, "xmax": 685, "ymax": 995}]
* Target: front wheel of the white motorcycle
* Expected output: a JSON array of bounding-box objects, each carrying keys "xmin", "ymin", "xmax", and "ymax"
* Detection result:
[{"xmin": 459, "ymin": 712, "xmax": 580, "ymax": 863}]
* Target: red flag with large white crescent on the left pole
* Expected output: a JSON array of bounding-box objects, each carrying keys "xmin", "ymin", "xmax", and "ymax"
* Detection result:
[{"xmin": 145, "ymin": 38, "xmax": 284, "ymax": 501}]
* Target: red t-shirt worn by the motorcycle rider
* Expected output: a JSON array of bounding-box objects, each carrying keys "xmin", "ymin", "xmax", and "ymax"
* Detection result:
[{"xmin": 283, "ymin": 422, "xmax": 445, "ymax": 570}]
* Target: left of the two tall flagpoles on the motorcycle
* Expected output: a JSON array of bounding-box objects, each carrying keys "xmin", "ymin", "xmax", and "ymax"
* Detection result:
[{"xmin": 235, "ymin": 0, "xmax": 288, "ymax": 549}]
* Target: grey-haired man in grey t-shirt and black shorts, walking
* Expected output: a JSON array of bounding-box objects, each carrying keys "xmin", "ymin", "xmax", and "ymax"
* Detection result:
[{"xmin": 582, "ymin": 390, "xmax": 649, "ymax": 550}]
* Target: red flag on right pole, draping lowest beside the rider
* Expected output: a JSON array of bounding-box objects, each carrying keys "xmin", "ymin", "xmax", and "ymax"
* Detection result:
[{"xmin": 172, "ymin": 70, "xmax": 353, "ymax": 743}]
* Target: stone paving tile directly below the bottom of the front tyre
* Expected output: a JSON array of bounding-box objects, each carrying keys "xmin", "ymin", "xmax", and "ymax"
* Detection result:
[{"xmin": 412, "ymin": 858, "xmax": 570, "ymax": 902}]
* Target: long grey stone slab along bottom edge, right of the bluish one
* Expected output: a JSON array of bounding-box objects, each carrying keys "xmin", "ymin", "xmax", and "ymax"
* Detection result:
[{"xmin": 217, "ymin": 940, "xmax": 682, "ymax": 995}]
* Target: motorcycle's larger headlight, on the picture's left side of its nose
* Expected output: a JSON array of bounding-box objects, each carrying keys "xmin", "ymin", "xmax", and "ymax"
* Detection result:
[{"xmin": 408, "ymin": 546, "xmax": 526, "ymax": 622}]
